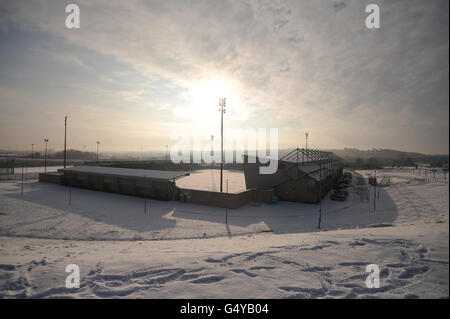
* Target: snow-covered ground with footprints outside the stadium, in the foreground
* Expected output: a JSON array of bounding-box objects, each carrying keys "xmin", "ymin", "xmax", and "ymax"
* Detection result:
[{"xmin": 0, "ymin": 170, "xmax": 449, "ymax": 298}]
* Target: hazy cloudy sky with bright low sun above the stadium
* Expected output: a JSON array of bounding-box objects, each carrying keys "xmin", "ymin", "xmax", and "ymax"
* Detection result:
[{"xmin": 0, "ymin": 0, "xmax": 449, "ymax": 154}]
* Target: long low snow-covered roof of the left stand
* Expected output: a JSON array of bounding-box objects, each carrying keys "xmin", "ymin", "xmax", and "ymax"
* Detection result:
[{"xmin": 58, "ymin": 165, "xmax": 189, "ymax": 181}]
